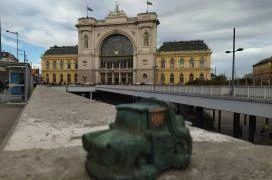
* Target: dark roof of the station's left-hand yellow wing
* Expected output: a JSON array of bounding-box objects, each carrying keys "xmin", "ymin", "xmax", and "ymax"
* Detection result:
[{"xmin": 44, "ymin": 45, "xmax": 78, "ymax": 55}]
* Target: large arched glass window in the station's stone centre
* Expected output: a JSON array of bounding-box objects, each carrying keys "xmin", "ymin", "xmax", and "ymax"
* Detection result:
[{"xmin": 100, "ymin": 34, "xmax": 133, "ymax": 84}]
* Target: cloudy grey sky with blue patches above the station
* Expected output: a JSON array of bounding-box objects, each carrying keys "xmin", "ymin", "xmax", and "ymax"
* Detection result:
[{"xmin": 0, "ymin": 0, "xmax": 272, "ymax": 76}]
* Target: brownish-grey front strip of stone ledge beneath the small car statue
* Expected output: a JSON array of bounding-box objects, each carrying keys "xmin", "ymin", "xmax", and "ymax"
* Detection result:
[{"xmin": 0, "ymin": 142, "xmax": 272, "ymax": 180}]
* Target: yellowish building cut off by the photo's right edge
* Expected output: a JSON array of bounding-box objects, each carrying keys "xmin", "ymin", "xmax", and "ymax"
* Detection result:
[{"xmin": 253, "ymin": 57, "xmax": 272, "ymax": 84}]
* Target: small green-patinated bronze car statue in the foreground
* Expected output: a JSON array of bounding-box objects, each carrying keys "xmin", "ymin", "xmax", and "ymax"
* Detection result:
[{"xmin": 82, "ymin": 99, "xmax": 192, "ymax": 180}]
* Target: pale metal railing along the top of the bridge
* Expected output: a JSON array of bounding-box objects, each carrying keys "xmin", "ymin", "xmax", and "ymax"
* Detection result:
[{"xmin": 96, "ymin": 85, "xmax": 272, "ymax": 100}]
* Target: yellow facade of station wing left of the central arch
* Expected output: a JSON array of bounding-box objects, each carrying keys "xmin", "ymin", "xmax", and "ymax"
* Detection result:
[{"xmin": 41, "ymin": 54, "xmax": 78, "ymax": 83}]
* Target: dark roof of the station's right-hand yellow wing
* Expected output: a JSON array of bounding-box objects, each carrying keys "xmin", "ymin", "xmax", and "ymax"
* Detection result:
[{"xmin": 159, "ymin": 40, "xmax": 209, "ymax": 51}]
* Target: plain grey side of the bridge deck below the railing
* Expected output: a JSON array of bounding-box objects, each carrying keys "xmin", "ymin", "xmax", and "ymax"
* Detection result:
[{"xmin": 96, "ymin": 87, "xmax": 272, "ymax": 118}]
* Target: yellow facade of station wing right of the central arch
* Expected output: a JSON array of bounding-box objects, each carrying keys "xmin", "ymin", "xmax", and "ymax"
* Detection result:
[{"xmin": 156, "ymin": 50, "xmax": 211, "ymax": 84}]
